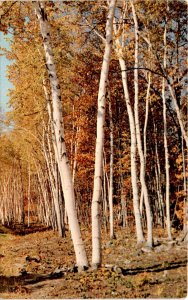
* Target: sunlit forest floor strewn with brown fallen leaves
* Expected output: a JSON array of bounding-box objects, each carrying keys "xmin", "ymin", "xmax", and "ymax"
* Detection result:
[{"xmin": 0, "ymin": 227, "xmax": 187, "ymax": 299}]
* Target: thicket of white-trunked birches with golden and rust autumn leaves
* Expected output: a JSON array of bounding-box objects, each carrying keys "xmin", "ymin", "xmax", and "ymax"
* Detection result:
[{"xmin": 0, "ymin": 0, "xmax": 188, "ymax": 268}]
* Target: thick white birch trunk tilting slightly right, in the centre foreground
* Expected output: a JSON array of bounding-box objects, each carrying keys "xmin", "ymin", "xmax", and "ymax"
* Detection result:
[{"xmin": 92, "ymin": 0, "xmax": 116, "ymax": 267}]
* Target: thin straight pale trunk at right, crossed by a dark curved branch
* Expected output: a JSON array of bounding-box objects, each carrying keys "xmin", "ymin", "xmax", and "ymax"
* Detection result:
[{"xmin": 162, "ymin": 24, "xmax": 172, "ymax": 240}]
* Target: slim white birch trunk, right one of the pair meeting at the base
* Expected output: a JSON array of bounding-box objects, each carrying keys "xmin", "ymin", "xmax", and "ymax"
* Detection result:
[{"xmin": 130, "ymin": 1, "xmax": 153, "ymax": 247}]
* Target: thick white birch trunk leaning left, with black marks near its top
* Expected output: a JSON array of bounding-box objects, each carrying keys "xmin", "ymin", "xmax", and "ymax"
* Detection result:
[{"xmin": 33, "ymin": 1, "xmax": 88, "ymax": 268}]
